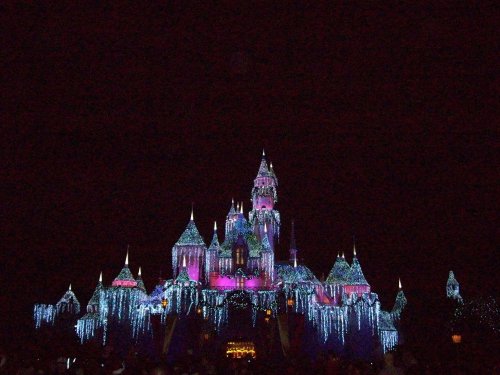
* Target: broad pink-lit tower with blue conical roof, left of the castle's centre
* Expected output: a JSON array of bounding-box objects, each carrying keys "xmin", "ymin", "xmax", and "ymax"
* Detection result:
[{"xmin": 172, "ymin": 211, "xmax": 207, "ymax": 282}]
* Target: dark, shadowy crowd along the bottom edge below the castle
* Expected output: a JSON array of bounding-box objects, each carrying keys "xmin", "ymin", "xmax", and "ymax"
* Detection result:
[{"xmin": 0, "ymin": 345, "xmax": 500, "ymax": 375}]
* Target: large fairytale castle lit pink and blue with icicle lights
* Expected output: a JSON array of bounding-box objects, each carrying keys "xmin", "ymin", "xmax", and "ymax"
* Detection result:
[{"xmin": 34, "ymin": 153, "xmax": 406, "ymax": 353}]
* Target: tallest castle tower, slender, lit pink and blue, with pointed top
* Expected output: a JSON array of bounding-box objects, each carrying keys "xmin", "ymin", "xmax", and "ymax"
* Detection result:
[{"xmin": 249, "ymin": 151, "xmax": 280, "ymax": 253}]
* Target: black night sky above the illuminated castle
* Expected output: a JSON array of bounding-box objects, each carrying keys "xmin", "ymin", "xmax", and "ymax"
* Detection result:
[{"xmin": 0, "ymin": 2, "xmax": 500, "ymax": 346}]
